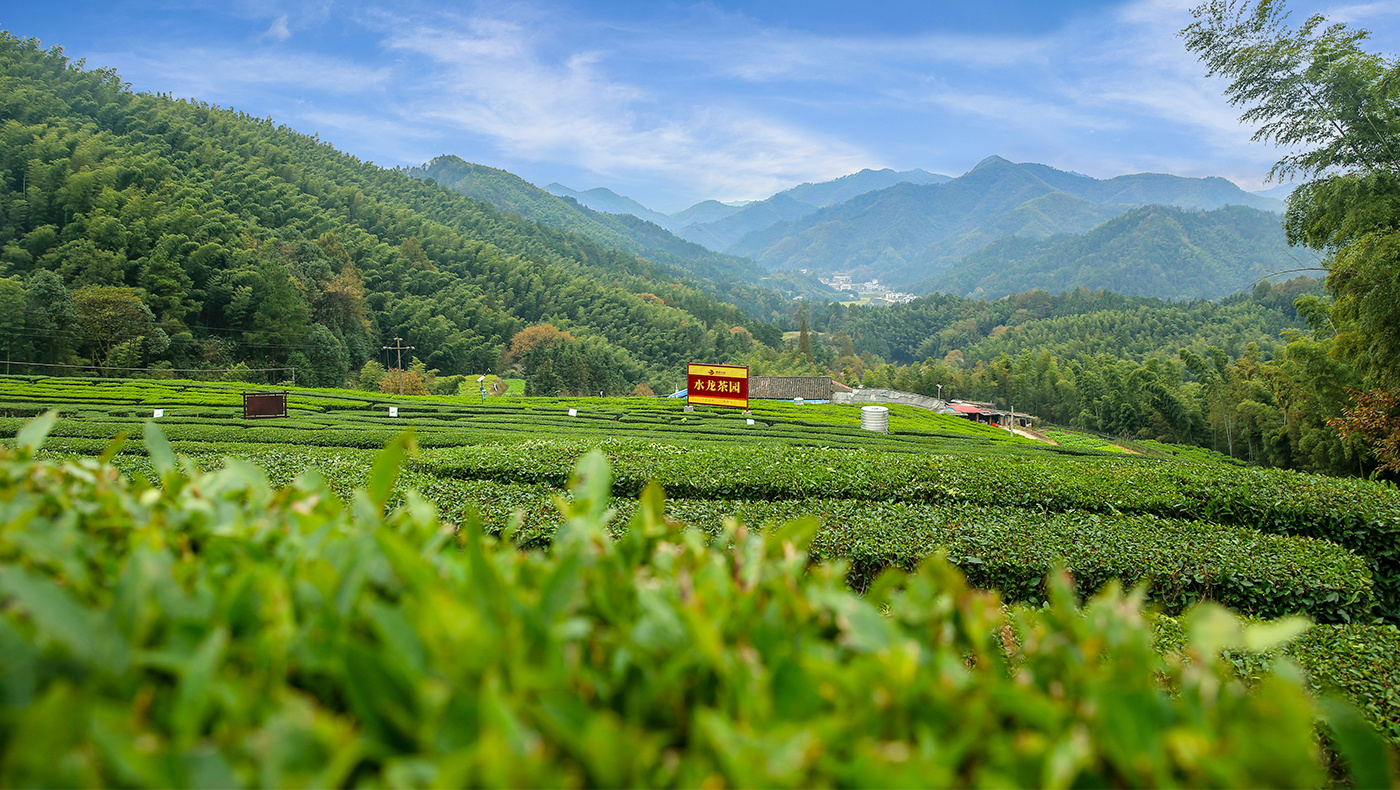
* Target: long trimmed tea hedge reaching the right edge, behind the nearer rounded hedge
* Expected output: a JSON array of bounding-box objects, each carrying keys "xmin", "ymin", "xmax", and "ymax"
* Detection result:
[{"xmin": 420, "ymin": 441, "xmax": 1400, "ymax": 619}]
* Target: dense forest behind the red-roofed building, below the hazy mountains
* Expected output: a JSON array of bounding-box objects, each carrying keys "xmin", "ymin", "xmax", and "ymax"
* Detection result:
[{"xmin": 742, "ymin": 277, "xmax": 1375, "ymax": 475}]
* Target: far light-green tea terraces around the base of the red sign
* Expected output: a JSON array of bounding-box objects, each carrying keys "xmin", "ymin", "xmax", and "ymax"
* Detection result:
[{"xmin": 0, "ymin": 377, "xmax": 1052, "ymax": 454}]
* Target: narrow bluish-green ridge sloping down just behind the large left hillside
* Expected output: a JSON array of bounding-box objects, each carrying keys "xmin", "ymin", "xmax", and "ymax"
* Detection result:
[{"xmin": 407, "ymin": 155, "xmax": 836, "ymax": 308}]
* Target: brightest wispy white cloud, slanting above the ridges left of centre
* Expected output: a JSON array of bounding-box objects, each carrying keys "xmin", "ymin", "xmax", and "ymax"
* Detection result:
[{"xmin": 372, "ymin": 8, "xmax": 874, "ymax": 199}]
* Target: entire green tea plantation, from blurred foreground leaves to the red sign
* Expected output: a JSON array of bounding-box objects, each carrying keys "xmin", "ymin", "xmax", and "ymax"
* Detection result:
[{"xmin": 0, "ymin": 377, "xmax": 1400, "ymax": 786}]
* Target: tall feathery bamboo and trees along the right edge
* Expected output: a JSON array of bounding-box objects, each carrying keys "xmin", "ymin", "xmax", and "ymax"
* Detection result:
[{"xmin": 1182, "ymin": 0, "xmax": 1400, "ymax": 465}]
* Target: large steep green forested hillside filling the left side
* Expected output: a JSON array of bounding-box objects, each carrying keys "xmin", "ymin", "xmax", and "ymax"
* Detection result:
[{"xmin": 0, "ymin": 34, "xmax": 776, "ymax": 392}]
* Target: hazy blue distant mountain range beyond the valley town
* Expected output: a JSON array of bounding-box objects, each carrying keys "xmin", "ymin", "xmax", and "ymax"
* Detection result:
[{"xmin": 421, "ymin": 157, "xmax": 1299, "ymax": 298}]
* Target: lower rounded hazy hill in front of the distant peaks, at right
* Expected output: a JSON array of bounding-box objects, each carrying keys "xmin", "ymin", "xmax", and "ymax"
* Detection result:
[{"xmin": 918, "ymin": 206, "xmax": 1313, "ymax": 300}]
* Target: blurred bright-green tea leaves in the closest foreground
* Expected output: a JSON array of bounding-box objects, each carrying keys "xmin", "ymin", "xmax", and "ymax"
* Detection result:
[{"xmin": 0, "ymin": 420, "xmax": 1393, "ymax": 787}]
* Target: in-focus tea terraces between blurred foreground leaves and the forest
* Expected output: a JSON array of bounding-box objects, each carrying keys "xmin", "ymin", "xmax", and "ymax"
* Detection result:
[{"xmin": 0, "ymin": 377, "xmax": 1400, "ymax": 742}]
